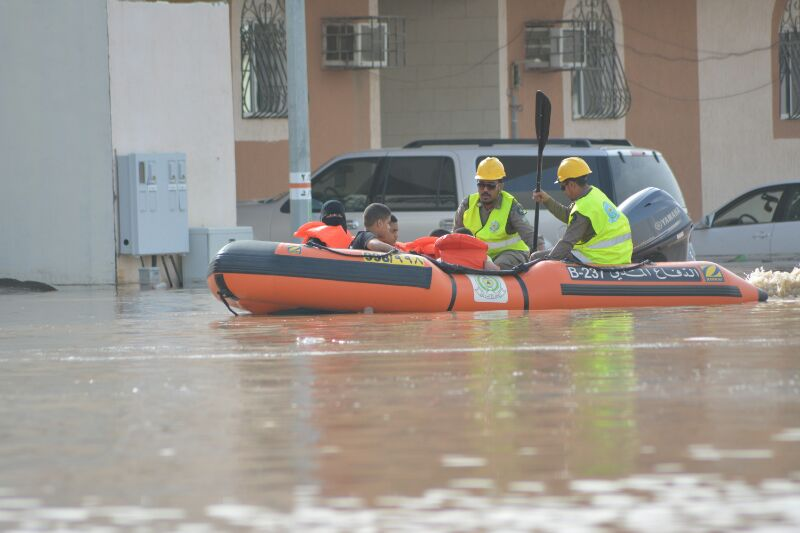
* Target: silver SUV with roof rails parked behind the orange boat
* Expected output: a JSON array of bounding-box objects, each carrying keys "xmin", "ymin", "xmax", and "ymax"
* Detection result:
[{"xmin": 237, "ymin": 139, "xmax": 686, "ymax": 248}]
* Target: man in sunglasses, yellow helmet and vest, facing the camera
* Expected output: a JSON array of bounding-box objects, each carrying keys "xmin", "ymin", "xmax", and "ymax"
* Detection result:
[{"xmin": 453, "ymin": 157, "xmax": 534, "ymax": 269}]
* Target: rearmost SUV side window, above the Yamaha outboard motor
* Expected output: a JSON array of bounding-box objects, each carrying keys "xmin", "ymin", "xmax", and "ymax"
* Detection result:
[{"xmin": 608, "ymin": 152, "xmax": 686, "ymax": 207}]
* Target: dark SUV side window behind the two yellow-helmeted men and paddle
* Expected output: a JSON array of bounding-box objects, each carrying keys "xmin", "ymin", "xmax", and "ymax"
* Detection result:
[{"xmin": 488, "ymin": 154, "xmax": 598, "ymax": 209}]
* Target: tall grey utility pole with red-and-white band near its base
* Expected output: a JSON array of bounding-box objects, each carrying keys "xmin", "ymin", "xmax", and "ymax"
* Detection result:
[{"xmin": 286, "ymin": 0, "xmax": 311, "ymax": 235}]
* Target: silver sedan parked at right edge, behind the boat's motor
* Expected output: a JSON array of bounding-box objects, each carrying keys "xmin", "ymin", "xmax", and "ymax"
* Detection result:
[{"xmin": 692, "ymin": 181, "xmax": 800, "ymax": 270}]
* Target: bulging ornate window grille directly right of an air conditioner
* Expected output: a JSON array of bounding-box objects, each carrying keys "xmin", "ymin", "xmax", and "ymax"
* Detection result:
[{"xmin": 572, "ymin": 0, "xmax": 631, "ymax": 119}]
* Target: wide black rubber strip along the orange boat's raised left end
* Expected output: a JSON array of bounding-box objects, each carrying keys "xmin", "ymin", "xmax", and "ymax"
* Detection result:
[{"xmin": 209, "ymin": 241, "xmax": 433, "ymax": 289}]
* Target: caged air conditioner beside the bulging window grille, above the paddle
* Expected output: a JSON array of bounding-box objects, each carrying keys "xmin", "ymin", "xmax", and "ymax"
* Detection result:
[{"xmin": 525, "ymin": 26, "xmax": 586, "ymax": 70}]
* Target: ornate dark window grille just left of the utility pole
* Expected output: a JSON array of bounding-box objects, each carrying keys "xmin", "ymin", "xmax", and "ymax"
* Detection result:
[{"xmin": 240, "ymin": 0, "xmax": 288, "ymax": 118}]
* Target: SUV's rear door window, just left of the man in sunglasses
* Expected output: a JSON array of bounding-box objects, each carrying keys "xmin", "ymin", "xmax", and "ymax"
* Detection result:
[{"xmin": 377, "ymin": 156, "xmax": 457, "ymax": 211}]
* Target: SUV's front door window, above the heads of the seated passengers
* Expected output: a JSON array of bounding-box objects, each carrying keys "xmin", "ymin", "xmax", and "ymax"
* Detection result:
[{"xmin": 311, "ymin": 157, "xmax": 381, "ymax": 213}]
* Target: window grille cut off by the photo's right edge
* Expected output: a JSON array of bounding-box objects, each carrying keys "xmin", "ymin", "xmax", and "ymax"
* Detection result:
[{"xmin": 778, "ymin": 0, "xmax": 800, "ymax": 120}]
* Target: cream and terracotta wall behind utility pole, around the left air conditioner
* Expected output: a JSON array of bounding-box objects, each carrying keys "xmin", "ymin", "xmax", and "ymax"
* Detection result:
[{"xmin": 230, "ymin": 0, "xmax": 381, "ymax": 201}]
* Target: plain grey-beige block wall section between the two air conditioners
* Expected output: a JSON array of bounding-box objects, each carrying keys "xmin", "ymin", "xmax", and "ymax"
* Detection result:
[{"xmin": 379, "ymin": 0, "xmax": 501, "ymax": 146}]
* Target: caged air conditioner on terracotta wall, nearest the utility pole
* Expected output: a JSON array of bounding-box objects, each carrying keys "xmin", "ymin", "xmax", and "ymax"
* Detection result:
[{"xmin": 323, "ymin": 21, "xmax": 389, "ymax": 68}]
